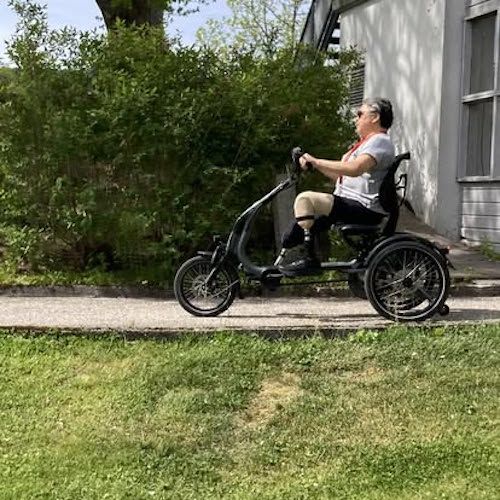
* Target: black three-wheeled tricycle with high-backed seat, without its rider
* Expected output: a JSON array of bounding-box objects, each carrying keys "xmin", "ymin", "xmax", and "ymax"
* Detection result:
[{"xmin": 174, "ymin": 147, "xmax": 450, "ymax": 322}]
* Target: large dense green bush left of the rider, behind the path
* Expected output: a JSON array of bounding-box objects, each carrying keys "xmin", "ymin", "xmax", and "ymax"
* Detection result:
[{"xmin": 0, "ymin": 2, "xmax": 353, "ymax": 280}]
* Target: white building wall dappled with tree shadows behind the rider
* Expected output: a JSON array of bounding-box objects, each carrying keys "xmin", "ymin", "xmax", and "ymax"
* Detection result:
[{"xmin": 341, "ymin": 0, "xmax": 448, "ymax": 230}]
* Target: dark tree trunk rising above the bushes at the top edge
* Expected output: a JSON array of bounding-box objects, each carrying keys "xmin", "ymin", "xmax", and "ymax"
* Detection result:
[{"xmin": 96, "ymin": 0, "xmax": 164, "ymax": 30}]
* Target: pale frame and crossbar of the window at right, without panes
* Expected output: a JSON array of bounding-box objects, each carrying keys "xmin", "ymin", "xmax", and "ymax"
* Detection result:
[{"xmin": 457, "ymin": 0, "xmax": 500, "ymax": 182}]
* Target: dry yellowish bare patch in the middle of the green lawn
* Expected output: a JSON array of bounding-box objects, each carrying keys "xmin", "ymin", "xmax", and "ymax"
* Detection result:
[{"xmin": 238, "ymin": 373, "xmax": 302, "ymax": 430}]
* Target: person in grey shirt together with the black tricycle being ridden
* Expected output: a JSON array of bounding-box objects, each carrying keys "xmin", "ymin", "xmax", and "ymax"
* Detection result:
[{"xmin": 174, "ymin": 99, "xmax": 450, "ymax": 321}]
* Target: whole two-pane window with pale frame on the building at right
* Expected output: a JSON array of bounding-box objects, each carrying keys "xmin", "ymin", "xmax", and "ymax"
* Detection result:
[{"xmin": 462, "ymin": 0, "xmax": 500, "ymax": 181}]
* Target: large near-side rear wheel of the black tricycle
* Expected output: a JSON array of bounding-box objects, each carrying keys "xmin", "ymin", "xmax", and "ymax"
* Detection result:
[{"xmin": 365, "ymin": 241, "xmax": 450, "ymax": 322}]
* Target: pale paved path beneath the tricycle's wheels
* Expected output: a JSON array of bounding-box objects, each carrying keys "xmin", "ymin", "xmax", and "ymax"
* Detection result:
[{"xmin": 0, "ymin": 296, "xmax": 500, "ymax": 335}]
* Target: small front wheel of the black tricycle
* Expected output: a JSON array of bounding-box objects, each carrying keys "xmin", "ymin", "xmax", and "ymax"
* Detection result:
[{"xmin": 174, "ymin": 255, "xmax": 239, "ymax": 316}]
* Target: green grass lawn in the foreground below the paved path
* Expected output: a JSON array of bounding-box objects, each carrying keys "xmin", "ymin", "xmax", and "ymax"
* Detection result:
[{"xmin": 0, "ymin": 325, "xmax": 500, "ymax": 500}]
